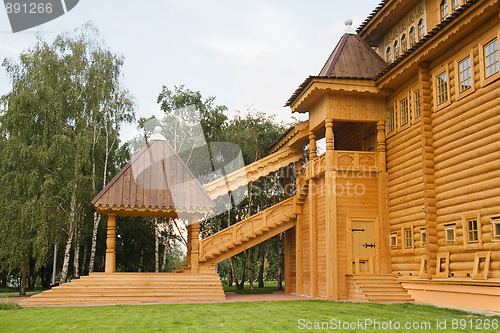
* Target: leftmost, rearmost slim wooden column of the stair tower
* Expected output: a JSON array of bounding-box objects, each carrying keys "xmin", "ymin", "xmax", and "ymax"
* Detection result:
[{"xmin": 295, "ymin": 160, "xmax": 304, "ymax": 295}]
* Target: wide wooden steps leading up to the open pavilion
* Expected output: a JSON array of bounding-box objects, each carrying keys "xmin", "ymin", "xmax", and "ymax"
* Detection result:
[{"xmin": 21, "ymin": 273, "xmax": 226, "ymax": 306}]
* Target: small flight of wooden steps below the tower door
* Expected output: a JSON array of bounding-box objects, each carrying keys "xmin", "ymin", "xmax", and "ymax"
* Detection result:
[{"xmin": 353, "ymin": 274, "xmax": 415, "ymax": 302}]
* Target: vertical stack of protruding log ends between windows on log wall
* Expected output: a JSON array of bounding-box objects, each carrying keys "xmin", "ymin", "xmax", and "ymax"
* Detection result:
[{"xmin": 418, "ymin": 63, "xmax": 438, "ymax": 278}]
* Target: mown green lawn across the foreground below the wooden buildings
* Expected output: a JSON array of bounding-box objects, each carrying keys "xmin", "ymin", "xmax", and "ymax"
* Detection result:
[{"xmin": 0, "ymin": 301, "xmax": 500, "ymax": 332}]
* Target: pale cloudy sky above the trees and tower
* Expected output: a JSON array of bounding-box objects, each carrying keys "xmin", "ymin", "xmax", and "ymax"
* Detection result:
[{"xmin": 0, "ymin": 0, "xmax": 380, "ymax": 139}]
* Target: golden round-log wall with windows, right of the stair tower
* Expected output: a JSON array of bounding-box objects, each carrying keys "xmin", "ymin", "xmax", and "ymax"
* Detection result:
[{"xmin": 380, "ymin": 1, "xmax": 500, "ymax": 278}]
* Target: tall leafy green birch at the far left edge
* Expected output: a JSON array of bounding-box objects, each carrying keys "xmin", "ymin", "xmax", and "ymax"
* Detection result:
[{"xmin": 0, "ymin": 24, "xmax": 134, "ymax": 292}]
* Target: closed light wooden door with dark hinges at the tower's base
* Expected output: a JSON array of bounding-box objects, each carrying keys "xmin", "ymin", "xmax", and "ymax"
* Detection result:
[{"xmin": 351, "ymin": 221, "xmax": 375, "ymax": 274}]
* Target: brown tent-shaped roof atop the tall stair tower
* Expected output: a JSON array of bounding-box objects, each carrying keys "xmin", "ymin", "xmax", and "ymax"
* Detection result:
[{"xmin": 319, "ymin": 33, "xmax": 387, "ymax": 79}]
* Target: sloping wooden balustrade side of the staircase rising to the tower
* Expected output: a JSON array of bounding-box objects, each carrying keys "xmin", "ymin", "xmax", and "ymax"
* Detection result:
[{"xmin": 196, "ymin": 197, "xmax": 297, "ymax": 264}]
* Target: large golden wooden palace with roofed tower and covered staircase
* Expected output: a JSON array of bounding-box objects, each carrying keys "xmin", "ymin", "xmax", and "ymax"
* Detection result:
[{"xmin": 23, "ymin": 0, "xmax": 500, "ymax": 311}]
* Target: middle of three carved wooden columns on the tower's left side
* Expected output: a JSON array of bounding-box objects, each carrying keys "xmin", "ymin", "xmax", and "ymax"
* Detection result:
[{"xmin": 309, "ymin": 132, "xmax": 318, "ymax": 298}]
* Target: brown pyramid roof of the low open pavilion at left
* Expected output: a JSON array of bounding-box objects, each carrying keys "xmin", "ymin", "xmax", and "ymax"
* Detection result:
[{"xmin": 91, "ymin": 130, "xmax": 214, "ymax": 217}]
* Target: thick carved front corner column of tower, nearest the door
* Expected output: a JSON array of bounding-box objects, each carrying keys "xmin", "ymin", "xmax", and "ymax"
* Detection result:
[{"xmin": 325, "ymin": 119, "xmax": 339, "ymax": 300}]
